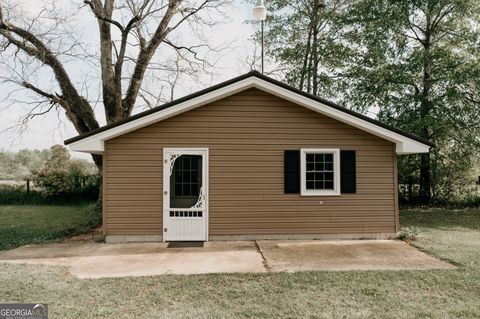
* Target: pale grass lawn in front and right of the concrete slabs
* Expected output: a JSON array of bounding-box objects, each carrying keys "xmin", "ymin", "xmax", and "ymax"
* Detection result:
[{"xmin": 0, "ymin": 210, "xmax": 480, "ymax": 318}]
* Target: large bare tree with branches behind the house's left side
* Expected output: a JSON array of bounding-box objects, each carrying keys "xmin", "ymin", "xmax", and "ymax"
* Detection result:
[{"xmin": 0, "ymin": 0, "xmax": 228, "ymax": 143}]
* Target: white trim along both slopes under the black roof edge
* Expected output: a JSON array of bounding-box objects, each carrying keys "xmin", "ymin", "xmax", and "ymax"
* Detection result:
[{"xmin": 69, "ymin": 76, "xmax": 430, "ymax": 154}]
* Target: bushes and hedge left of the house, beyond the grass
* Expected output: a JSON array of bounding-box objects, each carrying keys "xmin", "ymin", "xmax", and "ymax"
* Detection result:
[{"xmin": 0, "ymin": 145, "xmax": 100, "ymax": 204}]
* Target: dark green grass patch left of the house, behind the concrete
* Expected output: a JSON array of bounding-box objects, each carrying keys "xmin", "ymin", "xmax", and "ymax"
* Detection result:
[{"xmin": 0, "ymin": 203, "xmax": 100, "ymax": 250}]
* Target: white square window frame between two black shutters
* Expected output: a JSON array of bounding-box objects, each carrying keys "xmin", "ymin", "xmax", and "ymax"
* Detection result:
[{"xmin": 300, "ymin": 148, "xmax": 340, "ymax": 196}]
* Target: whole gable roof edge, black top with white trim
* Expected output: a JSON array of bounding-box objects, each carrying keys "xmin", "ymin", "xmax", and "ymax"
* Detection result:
[{"xmin": 64, "ymin": 71, "xmax": 434, "ymax": 154}]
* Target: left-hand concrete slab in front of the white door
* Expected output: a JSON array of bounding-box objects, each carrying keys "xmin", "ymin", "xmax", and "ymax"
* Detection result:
[{"xmin": 0, "ymin": 242, "xmax": 266, "ymax": 278}]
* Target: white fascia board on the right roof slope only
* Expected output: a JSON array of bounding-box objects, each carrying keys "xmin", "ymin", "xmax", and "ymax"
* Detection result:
[{"xmin": 251, "ymin": 78, "xmax": 430, "ymax": 154}]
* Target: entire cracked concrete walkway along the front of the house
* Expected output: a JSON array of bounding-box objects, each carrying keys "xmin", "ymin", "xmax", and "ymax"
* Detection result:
[{"xmin": 0, "ymin": 240, "xmax": 455, "ymax": 278}]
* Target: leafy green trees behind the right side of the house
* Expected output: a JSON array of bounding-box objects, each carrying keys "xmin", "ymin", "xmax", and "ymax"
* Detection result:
[{"xmin": 260, "ymin": 0, "xmax": 480, "ymax": 202}]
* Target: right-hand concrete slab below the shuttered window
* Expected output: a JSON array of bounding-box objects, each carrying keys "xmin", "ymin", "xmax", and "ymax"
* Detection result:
[{"xmin": 258, "ymin": 240, "xmax": 456, "ymax": 272}]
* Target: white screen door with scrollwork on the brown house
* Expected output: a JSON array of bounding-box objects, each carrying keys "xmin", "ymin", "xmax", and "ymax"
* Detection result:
[{"xmin": 163, "ymin": 148, "xmax": 208, "ymax": 241}]
